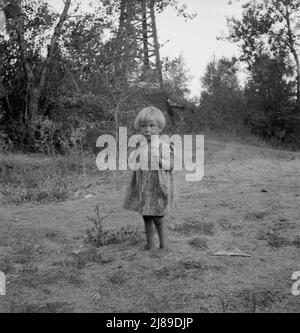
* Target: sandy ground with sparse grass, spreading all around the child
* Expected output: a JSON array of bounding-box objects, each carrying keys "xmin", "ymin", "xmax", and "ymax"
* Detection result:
[{"xmin": 0, "ymin": 140, "xmax": 300, "ymax": 313}]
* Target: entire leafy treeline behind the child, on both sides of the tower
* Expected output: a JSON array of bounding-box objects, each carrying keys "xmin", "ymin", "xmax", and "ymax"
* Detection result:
[{"xmin": 0, "ymin": 0, "xmax": 300, "ymax": 155}]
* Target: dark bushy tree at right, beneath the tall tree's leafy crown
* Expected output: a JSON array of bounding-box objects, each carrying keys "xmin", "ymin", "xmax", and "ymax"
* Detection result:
[{"xmin": 245, "ymin": 54, "xmax": 294, "ymax": 140}]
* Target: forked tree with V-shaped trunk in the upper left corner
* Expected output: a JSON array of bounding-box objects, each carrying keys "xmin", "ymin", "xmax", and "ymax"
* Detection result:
[{"xmin": 4, "ymin": 0, "xmax": 71, "ymax": 128}]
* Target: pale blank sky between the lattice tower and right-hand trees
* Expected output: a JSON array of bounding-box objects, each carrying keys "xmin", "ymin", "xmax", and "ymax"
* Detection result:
[{"xmin": 0, "ymin": 0, "xmax": 241, "ymax": 96}]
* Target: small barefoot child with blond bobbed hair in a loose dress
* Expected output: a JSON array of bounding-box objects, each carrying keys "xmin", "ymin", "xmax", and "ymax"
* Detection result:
[{"xmin": 124, "ymin": 106, "xmax": 175, "ymax": 251}]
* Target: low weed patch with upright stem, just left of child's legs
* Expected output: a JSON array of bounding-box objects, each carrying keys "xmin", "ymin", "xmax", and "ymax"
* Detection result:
[{"xmin": 85, "ymin": 205, "xmax": 143, "ymax": 247}]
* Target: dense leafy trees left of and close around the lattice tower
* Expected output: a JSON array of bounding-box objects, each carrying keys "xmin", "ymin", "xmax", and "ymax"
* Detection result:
[{"xmin": 0, "ymin": 0, "xmax": 190, "ymax": 154}]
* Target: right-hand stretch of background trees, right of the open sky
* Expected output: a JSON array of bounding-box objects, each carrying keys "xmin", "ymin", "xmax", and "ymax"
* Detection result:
[{"xmin": 193, "ymin": 0, "xmax": 300, "ymax": 147}]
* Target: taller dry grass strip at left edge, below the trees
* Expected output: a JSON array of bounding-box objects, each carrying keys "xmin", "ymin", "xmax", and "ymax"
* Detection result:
[{"xmin": 0, "ymin": 154, "xmax": 110, "ymax": 205}]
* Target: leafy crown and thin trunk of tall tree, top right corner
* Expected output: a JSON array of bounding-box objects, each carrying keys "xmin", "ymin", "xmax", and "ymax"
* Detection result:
[{"xmin": 228, "ymin": 0, "xmax": 300, "ymax": 105}]
